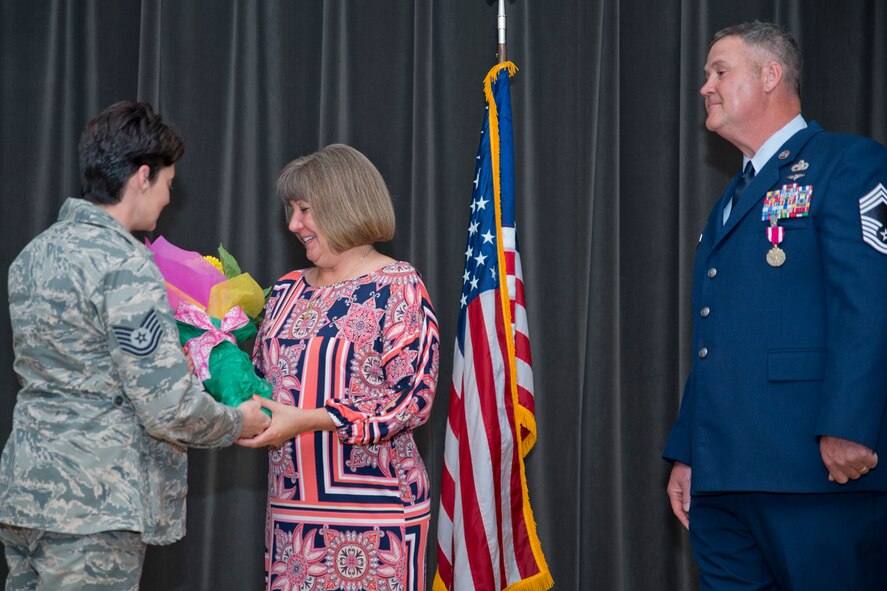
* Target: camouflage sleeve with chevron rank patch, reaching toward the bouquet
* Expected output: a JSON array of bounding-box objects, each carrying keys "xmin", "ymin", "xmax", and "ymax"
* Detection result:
[{"xmin": 99, "ymin": 259, "xmax": 243, "ymax": 447}]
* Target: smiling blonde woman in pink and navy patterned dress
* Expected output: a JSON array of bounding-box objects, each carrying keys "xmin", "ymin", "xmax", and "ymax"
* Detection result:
[{"xmin": 240, "ymin": 145, "xmax": 439, "ymax": 591}]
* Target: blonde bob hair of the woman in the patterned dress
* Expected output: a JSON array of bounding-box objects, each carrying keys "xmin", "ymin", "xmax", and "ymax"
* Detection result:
[{"xmin": 277, "ymin": 144, "xmax": 394, "ymax": 254}]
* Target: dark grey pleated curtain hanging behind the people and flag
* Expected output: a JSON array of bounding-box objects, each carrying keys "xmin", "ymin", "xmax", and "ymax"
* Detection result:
[{"xmin": 0, "ymin": 0, "xmax": 887, "ymax": 591}]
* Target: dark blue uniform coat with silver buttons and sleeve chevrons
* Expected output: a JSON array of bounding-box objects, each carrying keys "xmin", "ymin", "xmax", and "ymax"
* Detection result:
[{"xmin": 663, "ymin": 123, "xmax": 887, "ymax": 494}]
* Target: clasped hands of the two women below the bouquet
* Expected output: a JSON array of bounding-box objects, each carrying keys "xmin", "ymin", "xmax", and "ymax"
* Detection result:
[{"xmin": 235, "ymin": 396, "xmax": 335, "ymax": 448}]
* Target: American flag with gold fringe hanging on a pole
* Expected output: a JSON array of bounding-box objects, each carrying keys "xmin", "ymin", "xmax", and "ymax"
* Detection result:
[{"xmin": 434, "ymin": 62, "xmax": 554, "ymax": 591}]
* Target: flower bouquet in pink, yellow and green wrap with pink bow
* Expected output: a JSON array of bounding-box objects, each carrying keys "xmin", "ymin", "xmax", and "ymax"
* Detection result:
[{"xmin": 145, "ymin": 236, "xmax": 271, "ymax": 406}]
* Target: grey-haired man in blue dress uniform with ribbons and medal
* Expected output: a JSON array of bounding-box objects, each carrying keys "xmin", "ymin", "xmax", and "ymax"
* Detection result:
[{"xmin": 663, "ymin": 22, "xmax": 887, "ymax": 591}]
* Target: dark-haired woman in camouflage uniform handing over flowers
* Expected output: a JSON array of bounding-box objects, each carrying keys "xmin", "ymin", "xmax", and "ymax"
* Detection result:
[{"xmin": 0, "ymin": 102, "xmax": 269, "ymax": 591}]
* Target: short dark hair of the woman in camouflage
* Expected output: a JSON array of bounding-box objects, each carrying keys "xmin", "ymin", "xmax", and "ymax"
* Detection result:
[{"xmin": 78, "ymin": 101, "xmax": 185, "ymax": 205}]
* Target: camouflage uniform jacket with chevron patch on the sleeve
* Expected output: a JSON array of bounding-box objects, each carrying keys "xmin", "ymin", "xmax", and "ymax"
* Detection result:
[{"xmin": 0, "ymin": 199, "xmax": 243, "ymax": 544}]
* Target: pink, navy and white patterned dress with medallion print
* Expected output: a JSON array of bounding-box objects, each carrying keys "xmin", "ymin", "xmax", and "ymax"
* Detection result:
[{"xmin": 253, "ymin": 262, "xmax": 439, "ymax": 591}]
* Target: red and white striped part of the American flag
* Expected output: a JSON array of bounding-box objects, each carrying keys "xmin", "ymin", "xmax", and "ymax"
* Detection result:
[{"xmin": 435, "ymin": 228, "xmax": 550, "ymax": 591}]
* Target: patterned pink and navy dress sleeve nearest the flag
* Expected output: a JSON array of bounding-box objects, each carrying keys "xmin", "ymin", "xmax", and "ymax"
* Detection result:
[{"xmin": 326, "ymin": 275, "xmax": 440, "ymax": 445}]
